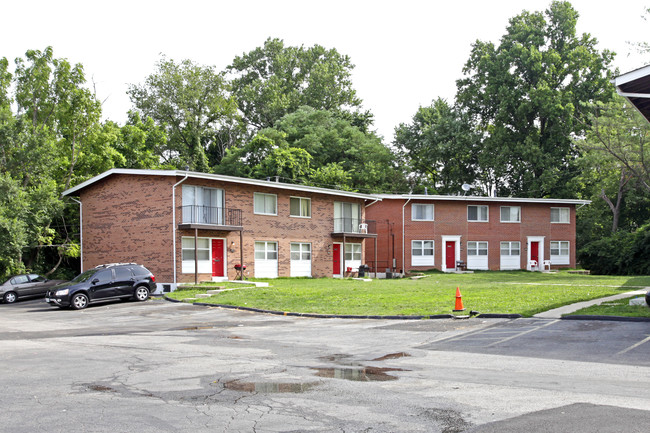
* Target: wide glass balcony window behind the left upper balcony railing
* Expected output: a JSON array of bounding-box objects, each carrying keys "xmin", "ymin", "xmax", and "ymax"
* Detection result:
[{"xmin": 183, "ymin": 185, "xmax": 224, "ymax": 224}]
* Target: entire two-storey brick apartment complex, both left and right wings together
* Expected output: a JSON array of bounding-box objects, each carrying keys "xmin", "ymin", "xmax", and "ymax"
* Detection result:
[{"xmin": 64, "ymin": 169, "xmax": 589, "ymax": 291}]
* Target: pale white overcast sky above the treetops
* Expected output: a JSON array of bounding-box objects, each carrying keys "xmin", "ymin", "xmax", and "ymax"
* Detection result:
[{"xmin": 5, "ymin": 0, "xmax": 650, "ymax": 142}]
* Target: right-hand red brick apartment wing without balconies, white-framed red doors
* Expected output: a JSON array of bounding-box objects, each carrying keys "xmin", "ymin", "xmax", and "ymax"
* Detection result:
[{"xmin": 366, "ymin": 195, "xmax": 590, "ymax": 273}]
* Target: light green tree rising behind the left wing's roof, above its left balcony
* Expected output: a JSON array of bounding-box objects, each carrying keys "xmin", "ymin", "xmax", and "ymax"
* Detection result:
[{"xmin": 127, "ymin": 57, "xmax": 236, "ymax": 171}]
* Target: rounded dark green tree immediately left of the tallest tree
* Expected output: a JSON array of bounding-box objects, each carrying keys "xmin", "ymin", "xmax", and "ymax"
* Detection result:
[{"xmin": 394, "ymin": 99, "xmax": 478, "ymax": 194}]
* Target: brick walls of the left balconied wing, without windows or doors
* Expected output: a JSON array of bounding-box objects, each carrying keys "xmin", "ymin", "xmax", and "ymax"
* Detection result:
[{"xmin": 81, "ymin": 175, "xmax": 364, "ymax": 283}]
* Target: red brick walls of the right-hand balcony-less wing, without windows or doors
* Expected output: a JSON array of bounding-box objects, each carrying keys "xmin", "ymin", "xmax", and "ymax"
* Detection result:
[{"xmin": 366, "ymin": 199, "xmax": 576, "ymax": 271}]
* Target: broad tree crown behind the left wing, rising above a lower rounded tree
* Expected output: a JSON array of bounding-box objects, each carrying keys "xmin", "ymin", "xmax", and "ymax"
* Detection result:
[{"xmin": 227, "ymin": 38, "xmax": 372, "ymax": 131}]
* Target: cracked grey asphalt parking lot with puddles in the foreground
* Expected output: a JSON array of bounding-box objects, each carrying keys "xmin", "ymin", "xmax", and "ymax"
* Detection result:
[{"xmin": 0, "ymin": 300, "xmax": 650, "ymax": 433}]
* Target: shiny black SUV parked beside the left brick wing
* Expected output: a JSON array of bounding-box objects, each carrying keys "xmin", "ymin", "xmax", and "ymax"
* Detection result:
[{"xmin": 45, "ymin": 263, "xmax": 156, "ymax": 310}]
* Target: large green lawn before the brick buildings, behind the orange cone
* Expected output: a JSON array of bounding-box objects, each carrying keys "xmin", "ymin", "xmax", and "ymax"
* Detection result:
[{"xmin": 169, "ymin": 271, "xmax": 650, "ymax": 316}]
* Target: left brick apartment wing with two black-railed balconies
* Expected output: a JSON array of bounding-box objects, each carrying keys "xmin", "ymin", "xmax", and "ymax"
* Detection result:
[{"xmin": 64, "ymin": 169, "xmax": 380, "ymax": 291}]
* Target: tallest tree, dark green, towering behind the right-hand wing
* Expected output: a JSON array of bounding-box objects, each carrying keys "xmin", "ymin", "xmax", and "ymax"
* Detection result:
[{"xmin": 457, "ymin": 1, "xmax": 613, "ymax": 197}]
